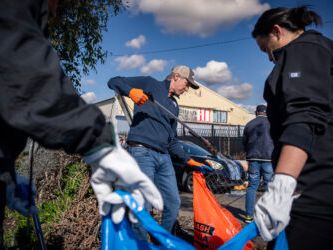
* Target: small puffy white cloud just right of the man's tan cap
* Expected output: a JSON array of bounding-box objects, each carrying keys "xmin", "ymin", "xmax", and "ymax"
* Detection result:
[{"xmin": 193, "ymin": 60, "xmax": 232, "ymax": 85}]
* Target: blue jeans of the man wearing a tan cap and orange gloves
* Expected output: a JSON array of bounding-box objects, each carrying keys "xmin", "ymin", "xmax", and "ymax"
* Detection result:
[{"xmin": 128, "ymin": 147, "xmax": 180, "ymax": 232}]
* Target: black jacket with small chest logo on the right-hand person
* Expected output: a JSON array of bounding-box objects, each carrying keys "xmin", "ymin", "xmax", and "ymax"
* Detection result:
[{"xmin": 264, "ymin": 31, "xmax": 333, "ymax": 217}]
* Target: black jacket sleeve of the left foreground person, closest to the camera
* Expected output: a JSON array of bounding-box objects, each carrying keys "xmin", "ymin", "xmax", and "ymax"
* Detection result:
[{"xmin": 0, "ymin": 0, "xmax": 113, "ymax": 160}]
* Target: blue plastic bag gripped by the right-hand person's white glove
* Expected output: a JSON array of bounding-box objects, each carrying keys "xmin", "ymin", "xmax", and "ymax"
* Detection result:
[{"xmin": 218, "ymin": 222, "xmax": 288, "ymax": 250}]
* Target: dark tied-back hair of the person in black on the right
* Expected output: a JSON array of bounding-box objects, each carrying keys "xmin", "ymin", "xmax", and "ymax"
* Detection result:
[{"xmin": 252, "ymin": 6, "xmax": 322, "ymax": 38}]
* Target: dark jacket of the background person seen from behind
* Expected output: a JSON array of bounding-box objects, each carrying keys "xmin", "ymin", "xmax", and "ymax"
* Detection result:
[{"xmin": 243, "ymin": 115, "xmax": 273, "ymax": 161}]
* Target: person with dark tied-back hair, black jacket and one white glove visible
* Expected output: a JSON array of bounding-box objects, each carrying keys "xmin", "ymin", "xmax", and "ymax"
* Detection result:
[{"xmin": 252, "ymin": 6, "xmax": 333, "ymax": 250}]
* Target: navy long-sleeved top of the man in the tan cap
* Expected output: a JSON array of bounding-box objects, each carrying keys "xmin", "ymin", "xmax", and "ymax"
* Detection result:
[{"xmin": 108, "ymin": 76, "xmax": 189, "ymax": 163}]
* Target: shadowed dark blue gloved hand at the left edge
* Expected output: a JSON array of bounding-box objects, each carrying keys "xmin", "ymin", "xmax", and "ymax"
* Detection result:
[{"xmin": 0, "ymin": 172, "xmax": 36, "ymax": 217}]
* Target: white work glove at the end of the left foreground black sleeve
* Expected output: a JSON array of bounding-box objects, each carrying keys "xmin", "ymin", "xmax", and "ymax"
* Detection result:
[{"xmin": 84, "ymin": 146, "xmax": 163, "ymax": 224}]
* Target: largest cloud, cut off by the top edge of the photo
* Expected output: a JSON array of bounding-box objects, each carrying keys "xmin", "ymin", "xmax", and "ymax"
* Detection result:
[{"xmin": 130, "ymin": 0, "xmax": 270, "ymax": 37}]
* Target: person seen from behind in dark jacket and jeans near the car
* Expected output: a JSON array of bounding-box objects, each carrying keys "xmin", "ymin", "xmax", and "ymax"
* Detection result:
[{"xmin": 243, "ymin": 105, "xmax": 273, "ymax": 223}]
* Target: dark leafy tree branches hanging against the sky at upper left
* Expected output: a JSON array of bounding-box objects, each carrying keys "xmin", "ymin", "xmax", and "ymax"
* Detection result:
[{"xmin": 49, "ymin": 0, "xmax": 126, "ymax": 90}]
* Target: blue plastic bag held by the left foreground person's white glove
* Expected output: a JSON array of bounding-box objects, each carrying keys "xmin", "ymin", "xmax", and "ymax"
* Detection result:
[{"xmin": 101, "ymin": 190, "xmax": 194, "ymax": 250}]
